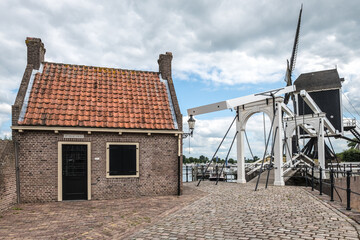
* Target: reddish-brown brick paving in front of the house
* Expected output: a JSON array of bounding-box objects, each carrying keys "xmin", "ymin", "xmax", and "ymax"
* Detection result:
[{"xmin": 0, "ymin": 187, "xmax": 205, "ymax": 239}]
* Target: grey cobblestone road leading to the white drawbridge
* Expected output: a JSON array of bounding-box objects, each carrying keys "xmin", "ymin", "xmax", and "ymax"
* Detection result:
[{"xmin": 129, "ymin": 182, "xmax": 359, "ymax": 239}]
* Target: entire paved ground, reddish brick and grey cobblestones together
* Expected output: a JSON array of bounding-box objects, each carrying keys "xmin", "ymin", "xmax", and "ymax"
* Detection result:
[{"xmin": 0, "ymin": 182, "xmax": 360, "ymax": 239}]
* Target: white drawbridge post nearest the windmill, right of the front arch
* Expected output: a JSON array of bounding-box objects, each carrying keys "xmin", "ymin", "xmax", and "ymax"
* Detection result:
[{"xmin": 274, "ymin": 99, "xmax": 285, "ymax": 186}]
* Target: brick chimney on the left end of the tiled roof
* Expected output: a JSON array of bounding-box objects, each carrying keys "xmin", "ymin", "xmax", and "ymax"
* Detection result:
[{"xmin": 25, "ymin": 37, "xmax": 46, "ymax": 70}]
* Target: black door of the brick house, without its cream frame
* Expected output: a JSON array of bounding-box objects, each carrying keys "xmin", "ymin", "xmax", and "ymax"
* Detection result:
[{"xmin": 62, "ymin": 144, "xmax": 87, "ymax": 200}]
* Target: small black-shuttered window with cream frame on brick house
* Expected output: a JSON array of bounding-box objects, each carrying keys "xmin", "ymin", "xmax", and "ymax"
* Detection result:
[{"xmin": 106, "ymin": 143, "xmax": 139, "ymax": 178}]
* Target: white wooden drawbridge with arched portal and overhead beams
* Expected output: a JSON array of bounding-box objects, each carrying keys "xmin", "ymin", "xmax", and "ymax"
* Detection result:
[{"xmin": 187, "ymin": 85, "xmax": 338, "ymax": 186}]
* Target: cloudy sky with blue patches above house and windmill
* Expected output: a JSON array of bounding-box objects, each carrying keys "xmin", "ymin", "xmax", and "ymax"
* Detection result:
[{"xmin": 0, "ymin": 0, "xmax": 360, "ymax": 157}]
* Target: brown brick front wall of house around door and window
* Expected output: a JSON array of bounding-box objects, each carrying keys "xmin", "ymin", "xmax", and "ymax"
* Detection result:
[{"xmin": 13, "ymin": 131, "xmax": 178, "ymax": 202}]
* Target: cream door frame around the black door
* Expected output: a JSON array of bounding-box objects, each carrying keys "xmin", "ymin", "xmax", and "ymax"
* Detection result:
[{"xmin": 58, "ymin": 141, "xmax": 91, "ymax": 201}]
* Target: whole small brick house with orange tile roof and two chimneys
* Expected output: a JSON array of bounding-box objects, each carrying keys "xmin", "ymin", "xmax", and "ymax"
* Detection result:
[{"xmin": 12, "ymin": 38, "xmax": 182, "ymax": 202}]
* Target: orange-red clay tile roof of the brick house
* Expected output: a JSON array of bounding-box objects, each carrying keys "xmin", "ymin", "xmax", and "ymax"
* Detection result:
[{"xmin": 19, "ymin": 62, "xmax": 175, "ymax": 129}]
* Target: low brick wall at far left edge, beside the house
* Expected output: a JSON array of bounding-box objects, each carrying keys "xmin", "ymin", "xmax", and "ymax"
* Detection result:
[{"xmin": 0, "ymin": 140, "xmax": 16, "ymax": 212}]
